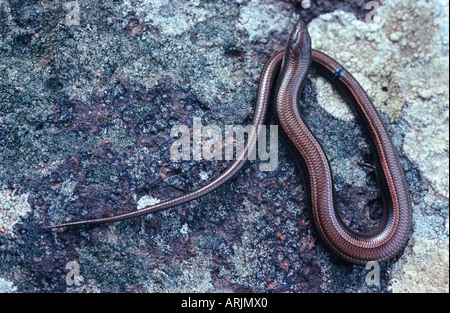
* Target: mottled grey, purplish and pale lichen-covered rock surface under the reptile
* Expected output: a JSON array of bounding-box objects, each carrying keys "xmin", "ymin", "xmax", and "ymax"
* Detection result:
[{"xmin": 0, "ymin": 0, "xmax": 449, "ymax": 292}]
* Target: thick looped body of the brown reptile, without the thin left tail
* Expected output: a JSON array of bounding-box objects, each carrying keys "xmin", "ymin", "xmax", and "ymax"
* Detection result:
[{"xmin": 276, "ymin": 21, "xmax": 412, "ymax": 264}]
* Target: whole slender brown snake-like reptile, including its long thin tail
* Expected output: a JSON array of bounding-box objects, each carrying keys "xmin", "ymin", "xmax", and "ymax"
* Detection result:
[{"xmin": 47, "ymin": 22, "xmax": 412, "ymax": 264}]
